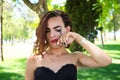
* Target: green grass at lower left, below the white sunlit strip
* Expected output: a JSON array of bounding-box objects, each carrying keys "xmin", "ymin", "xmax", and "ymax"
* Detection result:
[{"xmin": 0, "ymin": 58, "xmax": 26, "ymax": 80}]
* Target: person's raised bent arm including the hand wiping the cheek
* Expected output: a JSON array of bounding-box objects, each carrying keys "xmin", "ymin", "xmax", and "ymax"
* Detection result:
[{"xmin": 59, "ymin": 31, "xmax": 112, "ymax": 67}]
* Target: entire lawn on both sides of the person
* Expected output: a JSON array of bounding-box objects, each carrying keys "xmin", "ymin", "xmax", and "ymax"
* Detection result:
[{"xmin": 0, "ymin": 41, "xmax": 120, "ymax": 80}]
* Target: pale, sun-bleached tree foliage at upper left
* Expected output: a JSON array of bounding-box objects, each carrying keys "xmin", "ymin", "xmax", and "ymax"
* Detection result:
[{"xmin": 3, "ymin": 2, "xmax": 36, "ymax": 45}]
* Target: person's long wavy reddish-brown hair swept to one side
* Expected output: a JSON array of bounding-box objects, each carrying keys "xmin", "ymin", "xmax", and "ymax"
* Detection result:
[{"xmin": 33, "ymin": 10, "xmax": 72, "ymax": 55}]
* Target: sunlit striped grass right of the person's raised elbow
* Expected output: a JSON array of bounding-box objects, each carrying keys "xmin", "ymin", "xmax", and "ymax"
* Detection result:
[{"xmin": 96, "ymin": 41, "xmax": 120, "ymax": 64}]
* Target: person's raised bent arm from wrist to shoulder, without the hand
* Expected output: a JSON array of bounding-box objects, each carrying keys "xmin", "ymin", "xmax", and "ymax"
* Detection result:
[{"xmin": 75, "ymin": 33, "xmax": 112, "ymax": 67}]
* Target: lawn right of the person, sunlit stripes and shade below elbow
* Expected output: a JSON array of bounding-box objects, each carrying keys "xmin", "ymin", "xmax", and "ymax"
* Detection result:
[{"xmin": 78, "ymin": 41, "xmax": 120, "ymax": 80}]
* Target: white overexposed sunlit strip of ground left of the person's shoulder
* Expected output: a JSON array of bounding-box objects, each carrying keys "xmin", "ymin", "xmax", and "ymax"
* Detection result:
[{"xmin": 3, "ymin": 43, "xmax": 33, "ymax": 58}]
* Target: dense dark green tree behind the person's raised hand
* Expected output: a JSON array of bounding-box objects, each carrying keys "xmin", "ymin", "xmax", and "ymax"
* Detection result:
[{"xmin": 65, "ymin": 0, "xmax": 101, "ymax": 51}]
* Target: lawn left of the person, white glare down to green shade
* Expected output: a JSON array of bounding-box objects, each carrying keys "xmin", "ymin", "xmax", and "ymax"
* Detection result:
[{"xmin": 0, "ymin": 44, "xmax": 32, "ymax": 80}]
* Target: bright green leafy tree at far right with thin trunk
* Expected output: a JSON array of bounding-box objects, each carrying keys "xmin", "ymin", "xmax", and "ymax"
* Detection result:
[{"xmin": 98, "ymin": 0, "xmax": 120, "ymax": 40}]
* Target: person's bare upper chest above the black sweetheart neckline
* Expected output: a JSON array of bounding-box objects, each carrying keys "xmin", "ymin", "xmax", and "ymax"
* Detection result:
[{"xmin": 37, "ymin": 56, "xmax": 76, "ymax": 73}]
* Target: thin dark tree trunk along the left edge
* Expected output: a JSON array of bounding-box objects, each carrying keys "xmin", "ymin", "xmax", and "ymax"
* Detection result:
[{"xmin": 0, "ymin": 0, "xmax": 4, "ymax": 61}]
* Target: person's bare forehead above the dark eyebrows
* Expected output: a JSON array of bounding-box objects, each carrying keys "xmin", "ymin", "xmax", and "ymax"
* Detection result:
[{"xmin": 47, "ymin": 16, "xmax": 64, "ymax": 28}]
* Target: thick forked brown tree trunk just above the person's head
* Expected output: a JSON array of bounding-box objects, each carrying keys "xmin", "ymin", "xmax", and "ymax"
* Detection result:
[{"xmin": 23, "ymin": 0, "xmax": 48, "ymax": 18}]
